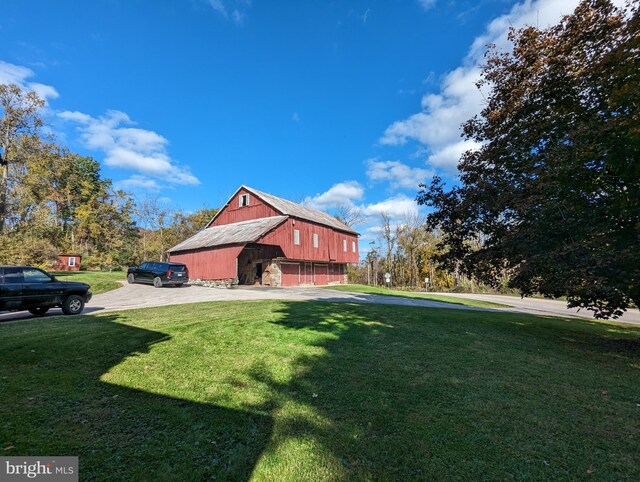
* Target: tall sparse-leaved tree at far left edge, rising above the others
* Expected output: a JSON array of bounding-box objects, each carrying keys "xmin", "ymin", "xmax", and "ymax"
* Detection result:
[{"xmin": 0, "ymin": 84, "xmax": 44, "ymax": 232}]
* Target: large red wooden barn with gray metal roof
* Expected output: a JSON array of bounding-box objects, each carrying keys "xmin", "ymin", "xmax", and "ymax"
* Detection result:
[{"xmin": 169, "ymin": 186, "xmax": 358, "ymax": 286}]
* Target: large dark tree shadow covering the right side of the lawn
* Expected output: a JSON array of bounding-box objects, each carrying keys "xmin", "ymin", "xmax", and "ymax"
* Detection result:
[{"xmin": 252, "ymin": 303, "xmax": 640, "ymax": 480}]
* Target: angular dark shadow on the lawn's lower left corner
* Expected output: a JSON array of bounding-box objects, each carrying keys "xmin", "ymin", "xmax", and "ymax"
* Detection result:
[{"xmin": 0, "ymin": 314, "xmax": 272, "ymax": 481}]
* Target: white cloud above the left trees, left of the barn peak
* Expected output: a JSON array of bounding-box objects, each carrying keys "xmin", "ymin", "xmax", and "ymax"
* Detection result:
[{"xmin": 58, "ymin": 110, "xmax": 200, "ymax": 185}]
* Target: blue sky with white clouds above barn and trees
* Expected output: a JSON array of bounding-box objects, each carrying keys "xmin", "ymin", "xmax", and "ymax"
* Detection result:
[{"xmin": 0, "ymin": 0, "xmax": 596, "ymax": 252}]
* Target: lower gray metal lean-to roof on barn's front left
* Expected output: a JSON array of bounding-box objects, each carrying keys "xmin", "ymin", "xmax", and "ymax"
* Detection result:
[{"xmin": 167, "ymin": 216, "xmax": 287, "ymax": 253}]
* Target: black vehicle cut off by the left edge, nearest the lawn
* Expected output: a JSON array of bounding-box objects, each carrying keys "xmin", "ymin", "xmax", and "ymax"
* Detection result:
[{"xmin": 0, "ymin": 266, "xmax": 91, "ymax": 316}]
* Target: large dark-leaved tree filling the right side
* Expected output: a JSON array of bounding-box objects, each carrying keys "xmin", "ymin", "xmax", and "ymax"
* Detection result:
[{"xmin": 417, "ymin": 0, "xmax": 640, "ymax": 318}]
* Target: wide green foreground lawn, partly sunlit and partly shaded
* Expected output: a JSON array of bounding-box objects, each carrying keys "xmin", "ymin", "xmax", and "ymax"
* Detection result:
[{"xmin": 0, "ymin": 301, "xmax": 640, "ymax": 481}]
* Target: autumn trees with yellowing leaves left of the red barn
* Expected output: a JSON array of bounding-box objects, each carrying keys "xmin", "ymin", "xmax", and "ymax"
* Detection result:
[{"xmin": 0, "ymin": 84, "xmax": 216, "ymax": 269}]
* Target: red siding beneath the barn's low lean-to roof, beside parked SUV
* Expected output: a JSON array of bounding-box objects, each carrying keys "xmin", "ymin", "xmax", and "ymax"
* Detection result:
[{"xmin": 171, "ymin": 245, "xmax": 244, "ymax": 280}]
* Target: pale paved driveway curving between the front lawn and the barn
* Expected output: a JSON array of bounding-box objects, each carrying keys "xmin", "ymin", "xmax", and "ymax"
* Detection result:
[{"xmin": 0, "ymin": 284, "xmax": 640, "ymax": 324}]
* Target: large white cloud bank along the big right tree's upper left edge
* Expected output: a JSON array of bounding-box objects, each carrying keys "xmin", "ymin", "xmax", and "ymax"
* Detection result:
[{"xmin": 379, "ymin": 0, "xmax": 624, "ymax": 172}]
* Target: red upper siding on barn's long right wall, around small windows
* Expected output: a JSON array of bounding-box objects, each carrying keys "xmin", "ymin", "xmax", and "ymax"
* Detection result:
[{"xmin": 258, "ymin": 218, "xmax": 359, "ymax": 263}]
